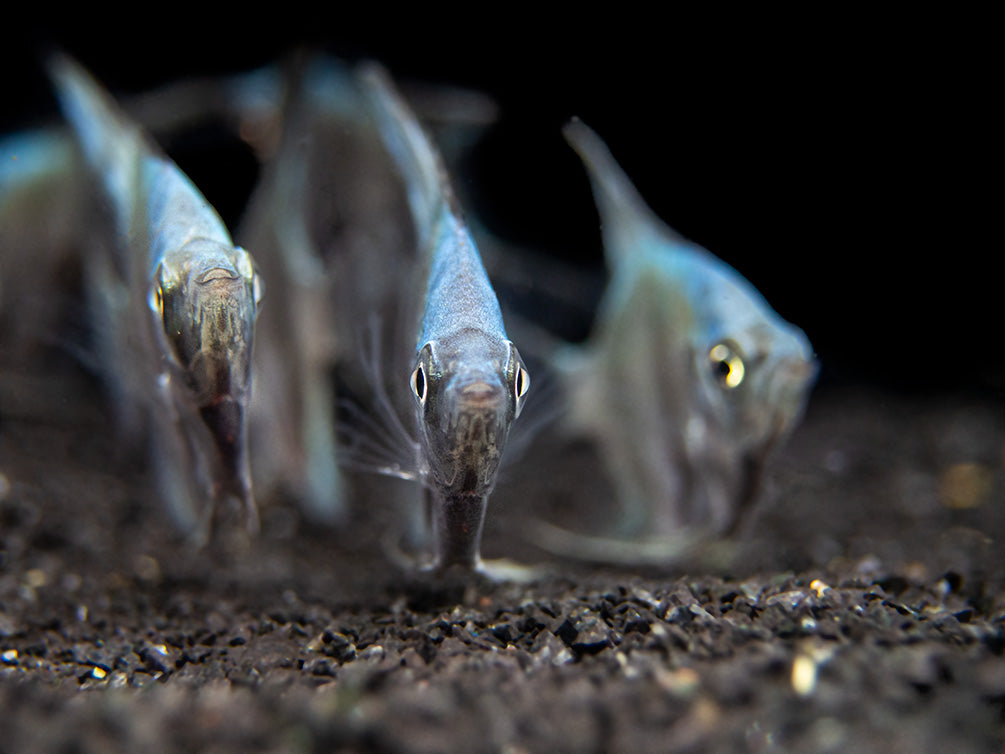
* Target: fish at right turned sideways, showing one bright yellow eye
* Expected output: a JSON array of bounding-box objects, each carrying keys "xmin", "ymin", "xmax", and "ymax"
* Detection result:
[{"xmin": 544, "ymin": 121, "xmax": 817, "ymax": 560}]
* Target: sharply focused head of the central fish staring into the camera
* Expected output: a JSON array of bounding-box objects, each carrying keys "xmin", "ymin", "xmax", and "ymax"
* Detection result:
[{"xmin": 410, "ymin": 329, "xmax": 531, "ymax": 498}]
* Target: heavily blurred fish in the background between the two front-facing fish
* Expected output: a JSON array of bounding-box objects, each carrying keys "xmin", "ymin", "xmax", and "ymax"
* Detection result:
[{"xmin": 239, "ymin": 56, "xmax": 413, "ymax": 522}]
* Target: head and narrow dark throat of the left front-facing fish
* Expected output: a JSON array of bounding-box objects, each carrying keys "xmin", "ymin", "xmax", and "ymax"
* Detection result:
[{"xmin": 150, "ymin": 239, "xmax": 261, "ymax": 494}]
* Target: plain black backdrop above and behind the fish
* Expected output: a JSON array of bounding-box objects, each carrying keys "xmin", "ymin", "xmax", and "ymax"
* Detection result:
[{"xmin": 0, "ymin": 16, "xmax": 1005, "ymax": 395}]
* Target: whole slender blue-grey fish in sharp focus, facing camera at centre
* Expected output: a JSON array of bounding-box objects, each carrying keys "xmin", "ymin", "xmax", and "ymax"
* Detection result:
[{"xmin": 361, "ymin": 65, "xmax": 531, "ymax": 569}]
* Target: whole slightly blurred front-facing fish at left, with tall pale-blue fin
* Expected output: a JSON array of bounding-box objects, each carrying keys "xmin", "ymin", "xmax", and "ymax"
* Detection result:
[{"xmin": 49, "ymin": 55, "xmax": 262, "ymax": 538}]
